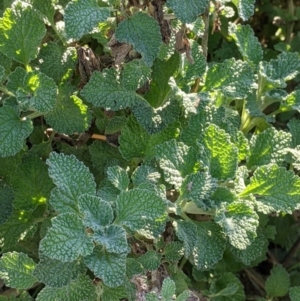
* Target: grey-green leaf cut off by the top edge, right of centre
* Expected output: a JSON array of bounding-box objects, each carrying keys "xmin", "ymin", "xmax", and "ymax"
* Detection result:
[{"xmin": 167, "ymin": 0, "xmax": 209, "ymax": 23}]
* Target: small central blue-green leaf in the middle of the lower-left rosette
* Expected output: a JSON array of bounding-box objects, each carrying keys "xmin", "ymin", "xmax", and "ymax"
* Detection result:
[{"xmin": 78, "ymin": 194, "xmax": 114, "ymax": 231}]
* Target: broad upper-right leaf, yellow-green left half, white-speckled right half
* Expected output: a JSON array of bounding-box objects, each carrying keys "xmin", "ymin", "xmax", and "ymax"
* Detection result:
[{"xmin": 203, "ymin": 59, "xmax": 255, "ymax": 99}]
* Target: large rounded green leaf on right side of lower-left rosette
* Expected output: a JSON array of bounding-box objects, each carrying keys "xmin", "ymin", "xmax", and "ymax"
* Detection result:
[{"xmin": 115, "ymin": 189, "xmax": 166, "ymax": 231}]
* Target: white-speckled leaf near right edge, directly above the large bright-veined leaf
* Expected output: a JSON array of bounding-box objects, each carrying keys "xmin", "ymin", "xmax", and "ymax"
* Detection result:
[{"xmin": 247, "ymin": 127, "xmax": 292, "ymax": 168}]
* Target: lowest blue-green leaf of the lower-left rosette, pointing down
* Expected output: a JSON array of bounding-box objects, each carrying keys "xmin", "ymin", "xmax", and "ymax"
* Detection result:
[{"xmin": 84, "ymin": 247, "xmax": 126, "ymax": 287}]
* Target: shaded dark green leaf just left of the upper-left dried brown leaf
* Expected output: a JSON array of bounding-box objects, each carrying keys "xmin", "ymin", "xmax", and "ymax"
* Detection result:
[{"xmin": 37, "ymin": 43, "xmax": 77, "ymax": 84}]
